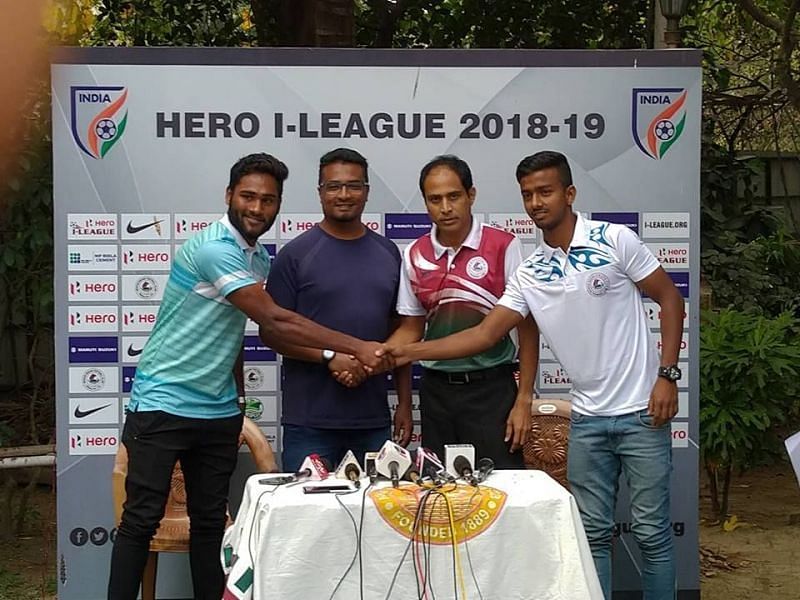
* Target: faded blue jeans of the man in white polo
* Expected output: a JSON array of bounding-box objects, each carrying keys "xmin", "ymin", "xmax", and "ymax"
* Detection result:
[{"xmin": 567, "ymin": 409, "xmax": 675, "ymax": 600}]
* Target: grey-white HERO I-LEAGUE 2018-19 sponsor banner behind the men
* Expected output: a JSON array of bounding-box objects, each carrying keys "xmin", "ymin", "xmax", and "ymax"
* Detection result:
[{"xmin": 52, "ymin": 48, "xmax": 701, "ymax": 600}]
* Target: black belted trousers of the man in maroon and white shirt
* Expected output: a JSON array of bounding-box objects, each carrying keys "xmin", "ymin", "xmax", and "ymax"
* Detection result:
[{"xmin": 419, "ymin": 365, "xmax": 524, "ymax": 469}]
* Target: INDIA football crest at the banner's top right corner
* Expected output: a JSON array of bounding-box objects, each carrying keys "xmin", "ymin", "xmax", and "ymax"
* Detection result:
[{"xmin": 631, "ymin": 88, "xmax": 687, "ymax": 160}]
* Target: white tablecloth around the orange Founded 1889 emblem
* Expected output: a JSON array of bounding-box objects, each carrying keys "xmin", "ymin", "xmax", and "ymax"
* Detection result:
[{"xmin": 222, "ymin": 470, "xmax": 603, "ymax": 600}]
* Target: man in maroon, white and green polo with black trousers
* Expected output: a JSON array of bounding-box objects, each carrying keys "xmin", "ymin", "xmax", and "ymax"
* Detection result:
[{"xmin": 387, "ymin": 155, "xmax": 539, "ymax": 468}]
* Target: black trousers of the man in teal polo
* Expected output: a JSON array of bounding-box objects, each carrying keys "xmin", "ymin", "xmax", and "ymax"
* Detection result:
[{"xmin": 108, "ymin": 411, "xmax": 242, "ymax": 600}]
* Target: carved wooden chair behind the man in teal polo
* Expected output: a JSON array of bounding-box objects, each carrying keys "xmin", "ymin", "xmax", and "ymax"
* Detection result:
[{"xmin": 112, "ymin": 417, "xmax": 278, "ymax": 600}]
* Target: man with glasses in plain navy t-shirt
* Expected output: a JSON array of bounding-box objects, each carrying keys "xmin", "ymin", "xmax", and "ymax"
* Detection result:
[{"xmin": 262, "ymin": 148, "xmax": 412, "ymax": 471}]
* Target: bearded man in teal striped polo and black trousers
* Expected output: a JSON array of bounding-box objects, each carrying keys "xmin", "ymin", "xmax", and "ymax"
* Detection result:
[{"xmin": 108, "ymin": 153, "xmax": 391, "ymax": 600}]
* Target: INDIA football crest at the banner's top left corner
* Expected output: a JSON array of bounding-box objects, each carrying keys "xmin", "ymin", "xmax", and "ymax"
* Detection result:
[{"xmin": 70, "ymin": 85, "xmax": 128, "ymax": 159}]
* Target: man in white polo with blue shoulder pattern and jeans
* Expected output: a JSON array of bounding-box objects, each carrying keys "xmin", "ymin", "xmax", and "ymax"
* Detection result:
[{"xmin": 390, "ymin": 151, "xmax": 684, "ymax": 600}]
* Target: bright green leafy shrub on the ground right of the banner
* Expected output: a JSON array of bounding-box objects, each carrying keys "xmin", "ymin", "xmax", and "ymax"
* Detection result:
[{"xmin": 700, "ymin": 309, "xmax": 800, "ymax": 521}]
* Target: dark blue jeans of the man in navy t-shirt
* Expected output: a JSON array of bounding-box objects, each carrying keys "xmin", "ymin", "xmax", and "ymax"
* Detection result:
[{"xmin": 281, "ymin": 425, "xmax": 392, "ymax": 472}]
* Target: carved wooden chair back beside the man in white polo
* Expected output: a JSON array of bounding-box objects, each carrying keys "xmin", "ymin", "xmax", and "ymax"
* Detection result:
[{"xmin": 523, "ymin": 398, "xmax": 570, "ymax": 489}]
